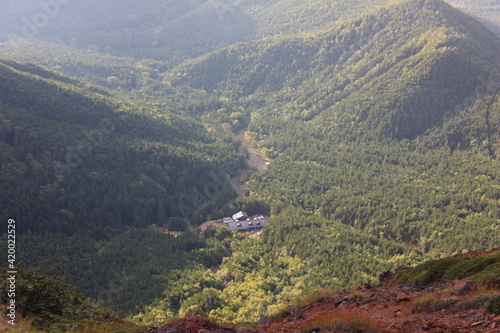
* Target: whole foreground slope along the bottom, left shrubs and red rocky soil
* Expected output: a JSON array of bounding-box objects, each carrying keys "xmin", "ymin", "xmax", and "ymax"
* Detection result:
[{"xmin": 0, "ymin": 249, "xmax": 500, "ymax": 333}]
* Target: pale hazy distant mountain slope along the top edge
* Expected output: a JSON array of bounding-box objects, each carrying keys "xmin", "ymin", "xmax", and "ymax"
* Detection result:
[{"xmin": 0, "ymin": 0, "xmax": 398, "ymax": 63}]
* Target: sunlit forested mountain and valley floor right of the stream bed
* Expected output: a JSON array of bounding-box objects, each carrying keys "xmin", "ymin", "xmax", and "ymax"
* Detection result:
[{"xmin": 135, "ymin": 1, "xmax": 500, "ymax": 323}]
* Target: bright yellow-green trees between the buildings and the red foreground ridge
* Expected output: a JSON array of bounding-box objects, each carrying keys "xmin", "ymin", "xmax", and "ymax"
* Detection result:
[{"xmin": 133, "ymin": 208, "xmax": 422, "ymax": 326}]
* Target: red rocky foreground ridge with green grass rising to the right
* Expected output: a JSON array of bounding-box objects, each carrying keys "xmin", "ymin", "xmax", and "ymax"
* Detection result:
[{"xmin": 148, "ymin": 248, "xmax": 500, "ymax": 333}]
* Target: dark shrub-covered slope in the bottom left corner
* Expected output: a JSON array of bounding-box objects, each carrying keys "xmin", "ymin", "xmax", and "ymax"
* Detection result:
[{"xmin": 0, "ymin": 267, "xmax": 146, "ymax": 333}]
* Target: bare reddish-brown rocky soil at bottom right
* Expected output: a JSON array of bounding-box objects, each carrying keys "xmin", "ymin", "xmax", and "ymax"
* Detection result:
[{"xmin": 241, "ymin": 288, "xmax": 500, "ymax": 333}]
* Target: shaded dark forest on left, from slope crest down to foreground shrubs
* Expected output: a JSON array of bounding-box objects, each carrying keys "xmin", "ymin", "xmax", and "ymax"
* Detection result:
[{"xmin": 0, "ymin": 60, "xmax": 243, "ymax": 311}]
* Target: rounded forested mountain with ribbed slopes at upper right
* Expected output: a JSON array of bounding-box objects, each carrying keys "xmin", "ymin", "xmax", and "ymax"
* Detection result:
[{"xmin": 166, "ymin": 1, "xmax": 500, "ymax": 139}]
